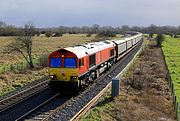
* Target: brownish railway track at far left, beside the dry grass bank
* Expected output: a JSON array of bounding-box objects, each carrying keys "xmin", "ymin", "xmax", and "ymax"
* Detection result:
[{"xmin": 0, "ymin": 77, "xmax": 49, "ymax": 113}]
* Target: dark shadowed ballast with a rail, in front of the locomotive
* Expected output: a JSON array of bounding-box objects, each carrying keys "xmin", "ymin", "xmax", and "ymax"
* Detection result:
[{"xmin": 0, "ymin": 88, "xmax": 67, "ymax": 121}]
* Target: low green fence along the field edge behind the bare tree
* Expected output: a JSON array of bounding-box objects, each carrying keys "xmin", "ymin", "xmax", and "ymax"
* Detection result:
[{"xmin": 0, "ymin": 55, "xmax": 48, "ymax": 74}]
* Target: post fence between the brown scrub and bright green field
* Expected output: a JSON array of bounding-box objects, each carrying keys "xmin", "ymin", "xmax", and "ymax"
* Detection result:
[{"xmin": 161, "ymin": 48, "xmax": 180, "ymax": 121}]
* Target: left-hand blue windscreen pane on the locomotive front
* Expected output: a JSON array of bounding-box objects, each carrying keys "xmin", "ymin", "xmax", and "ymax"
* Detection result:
[{"xmin": 50, "ymin": 58, "xmax": 62, "ymax": 68}]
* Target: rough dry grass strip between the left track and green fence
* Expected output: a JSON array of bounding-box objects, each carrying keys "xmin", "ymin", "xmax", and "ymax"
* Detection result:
[{"xmin": 0, "ymin": 67, "xmax": 48, "ymax": 95}]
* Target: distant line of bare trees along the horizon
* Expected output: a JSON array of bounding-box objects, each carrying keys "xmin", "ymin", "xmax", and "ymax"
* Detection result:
[{"xmin": 0, "ymin": 21, "xmax": 180, "ymax": 36}]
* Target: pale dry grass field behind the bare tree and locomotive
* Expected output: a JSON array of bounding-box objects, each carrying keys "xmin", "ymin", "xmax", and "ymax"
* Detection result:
[{"xmin": 0, "ymin": 34, "xmax": 94, "ymax": 65}]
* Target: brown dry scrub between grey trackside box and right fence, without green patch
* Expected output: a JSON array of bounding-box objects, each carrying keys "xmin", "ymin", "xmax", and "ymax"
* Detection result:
[{"xmin": 115, "ymin": 41, "xmax": 175, "ymax": 121}]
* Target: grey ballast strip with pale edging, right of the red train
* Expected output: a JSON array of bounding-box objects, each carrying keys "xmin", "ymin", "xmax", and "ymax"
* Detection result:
[{"xmin": 46, "ymin": 38, "xmax": 143, "ymax": 121}]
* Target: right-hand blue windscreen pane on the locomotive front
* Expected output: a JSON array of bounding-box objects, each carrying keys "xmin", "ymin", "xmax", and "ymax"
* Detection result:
[{"xmin": 64, "ymin": 58, "xmax": 76, "ymax": 68}]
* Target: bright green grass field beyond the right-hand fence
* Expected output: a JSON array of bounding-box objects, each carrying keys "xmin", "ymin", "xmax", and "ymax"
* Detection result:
[{"xmin": 162, "ymin": 36, "xmax": 180, "ymax": 102}]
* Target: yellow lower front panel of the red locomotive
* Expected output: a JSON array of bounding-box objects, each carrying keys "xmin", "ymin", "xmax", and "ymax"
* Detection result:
[{"xmin": 49, "ymin": 68, "xmax": 78, "ymax": 81}]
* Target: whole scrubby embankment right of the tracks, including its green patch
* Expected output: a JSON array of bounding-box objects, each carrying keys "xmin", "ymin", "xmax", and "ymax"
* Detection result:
[{"xmin": 82, "ymin": 41, "xmax": 175, "ymax": 121}]
